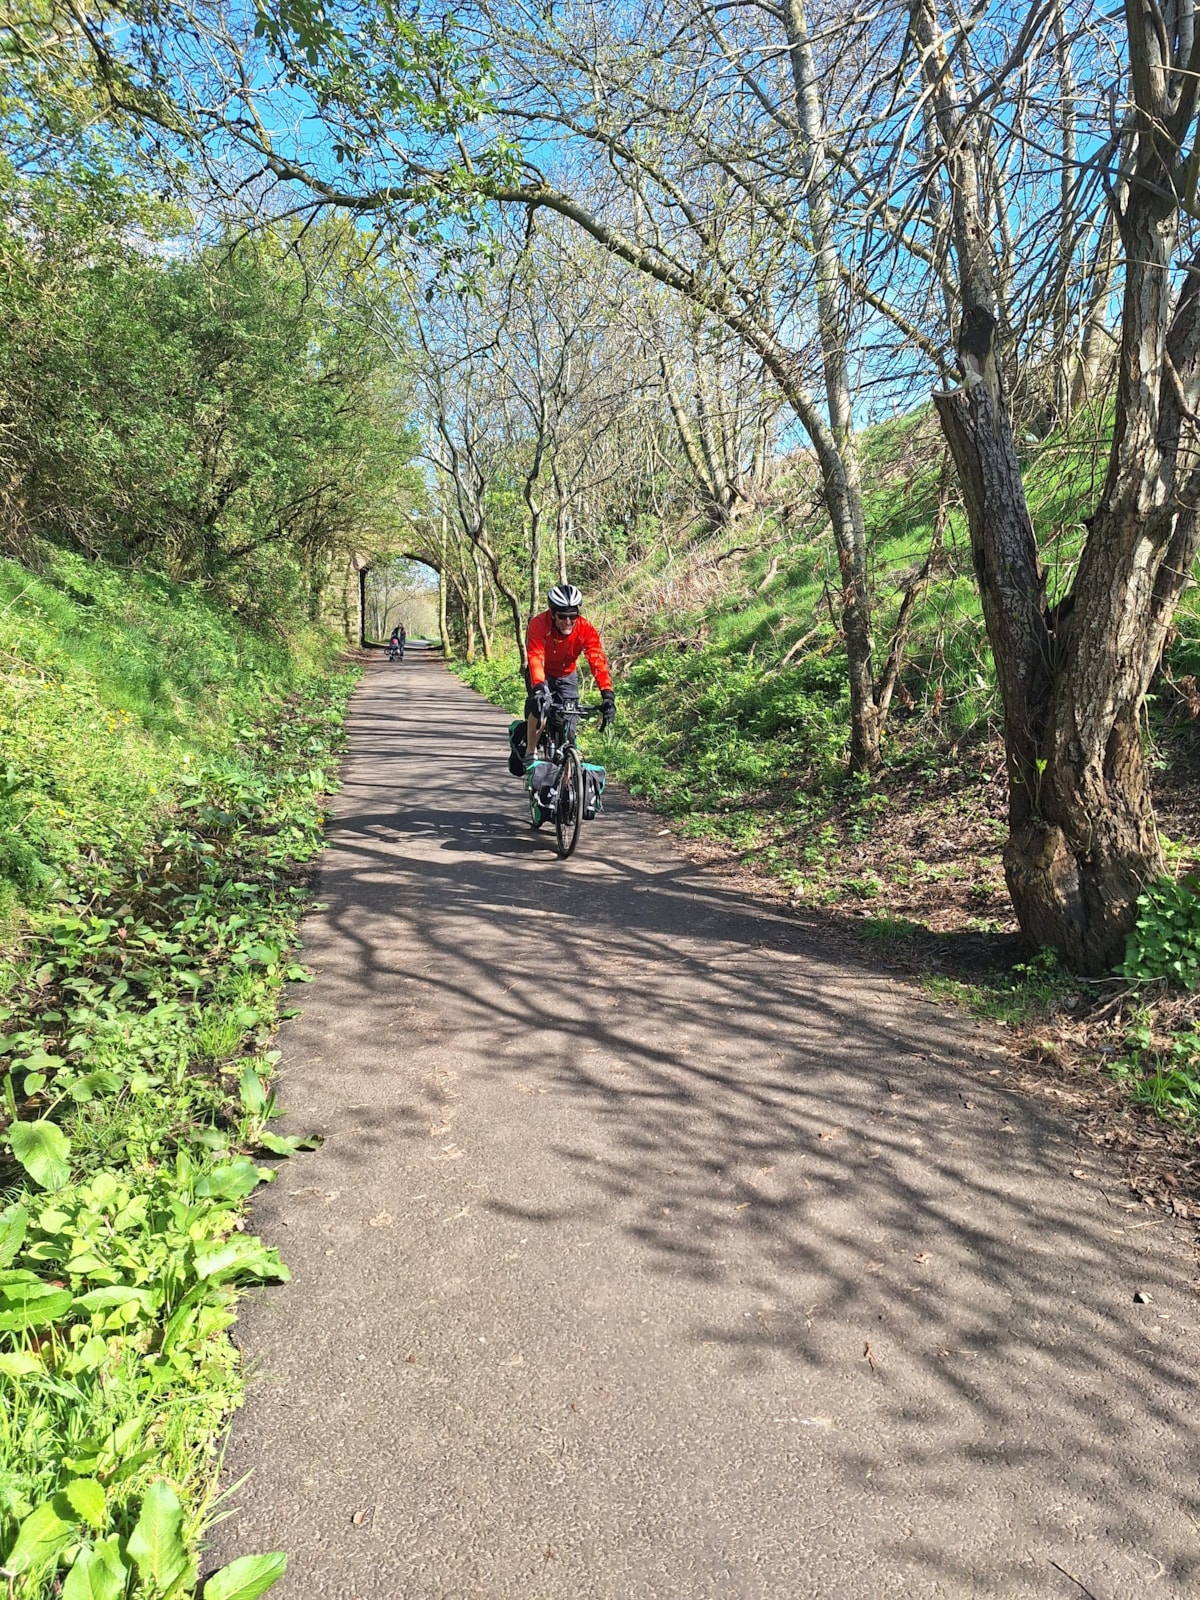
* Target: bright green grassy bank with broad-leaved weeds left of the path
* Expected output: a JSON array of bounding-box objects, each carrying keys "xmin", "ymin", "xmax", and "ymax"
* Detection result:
[{"xmin": 0, "ymin": 555, "xmax": 354, "ymax": 1600}]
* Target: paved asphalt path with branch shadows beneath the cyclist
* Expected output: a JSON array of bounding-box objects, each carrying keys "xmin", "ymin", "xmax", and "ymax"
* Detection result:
[{"xmin": 210, "ymin": 651, "xmax": 1200, "ymax": 1600}]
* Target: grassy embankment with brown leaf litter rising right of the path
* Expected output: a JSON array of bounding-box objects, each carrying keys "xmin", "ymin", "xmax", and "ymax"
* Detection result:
[{"xmin": 458, "ymin": 413, "xmax": 1200, "ymax": 1139}]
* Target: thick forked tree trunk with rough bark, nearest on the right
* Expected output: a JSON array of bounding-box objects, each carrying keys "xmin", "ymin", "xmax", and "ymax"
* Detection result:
[{"xmin": 914, "ymin": 0, "xmax": 1200, "ymax": 973}]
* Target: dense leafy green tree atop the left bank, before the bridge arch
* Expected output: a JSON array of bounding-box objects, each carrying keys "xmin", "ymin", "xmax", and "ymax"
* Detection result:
[{"xmin": 0, "ymin": 174, "xmax": 413, "ymax": 610}]
